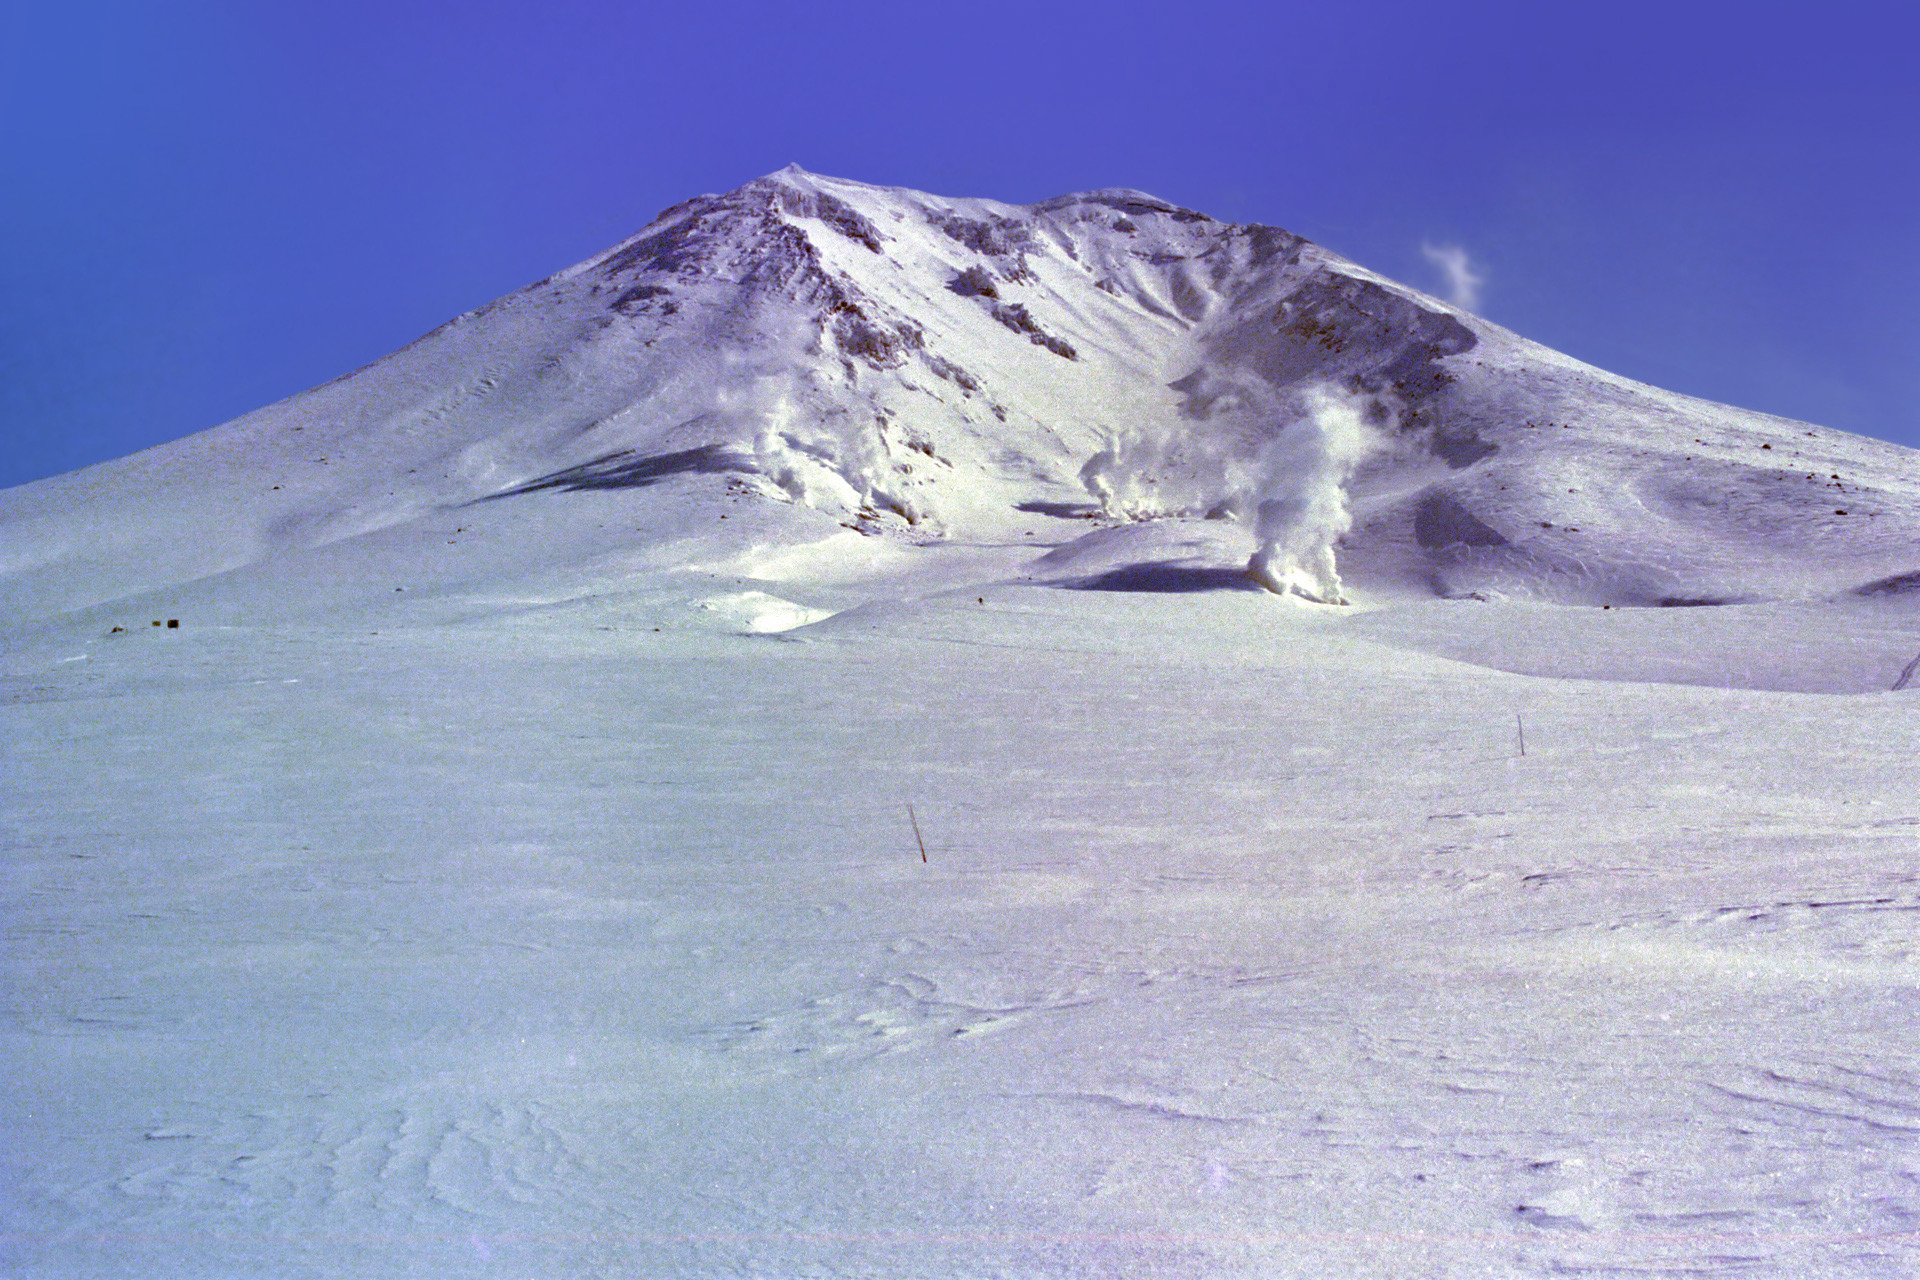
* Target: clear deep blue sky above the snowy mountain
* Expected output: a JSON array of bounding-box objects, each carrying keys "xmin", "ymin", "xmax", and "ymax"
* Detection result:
[{"xmin": 0, "ymin": 0, "xmax": 1920, "ymax": 484}]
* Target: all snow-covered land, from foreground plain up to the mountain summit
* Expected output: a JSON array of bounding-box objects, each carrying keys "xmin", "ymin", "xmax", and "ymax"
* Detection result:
[{"xmin": 0, "ymin": 169, "xmax": 1920, "ymax": 1278}]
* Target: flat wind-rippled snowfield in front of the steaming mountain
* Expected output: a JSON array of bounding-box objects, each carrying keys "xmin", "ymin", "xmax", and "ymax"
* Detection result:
[{"xmin": 0, "ymin": 571, "xmax": 1920, "ymax": 1278}]
